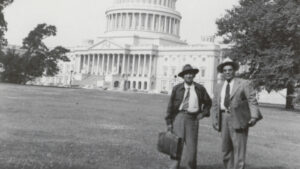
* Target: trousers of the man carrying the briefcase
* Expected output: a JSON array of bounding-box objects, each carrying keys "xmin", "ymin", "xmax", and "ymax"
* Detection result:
[{"xmin": 171, "ymin": 113, "xmax": 199, "ymax": 169}]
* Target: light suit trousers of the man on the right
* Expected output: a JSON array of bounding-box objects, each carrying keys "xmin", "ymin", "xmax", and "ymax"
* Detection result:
[{"xmin": 221, "ymin": 113, "xmax": 248, "ymax": 169}]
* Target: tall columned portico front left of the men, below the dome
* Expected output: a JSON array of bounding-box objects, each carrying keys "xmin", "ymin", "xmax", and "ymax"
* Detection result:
[{"xmin": 75, "ymin": 46, "xmax": 154, "ymax": 91}]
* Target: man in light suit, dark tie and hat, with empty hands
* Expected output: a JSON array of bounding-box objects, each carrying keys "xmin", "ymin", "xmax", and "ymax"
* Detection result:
[{"xmin": 211, "ymin": 58, "xmax": 262, "ymax": 169}]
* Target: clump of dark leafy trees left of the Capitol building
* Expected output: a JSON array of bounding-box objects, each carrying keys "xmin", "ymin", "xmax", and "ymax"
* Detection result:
[{"xmin": 0, "ymin": 24, "xmax": 69, "ymax": 84}]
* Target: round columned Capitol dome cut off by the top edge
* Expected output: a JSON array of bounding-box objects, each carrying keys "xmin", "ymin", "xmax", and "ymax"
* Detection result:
[{"xmin": 104, "ymin": 0, "xmax": 185, "ymax": 45}]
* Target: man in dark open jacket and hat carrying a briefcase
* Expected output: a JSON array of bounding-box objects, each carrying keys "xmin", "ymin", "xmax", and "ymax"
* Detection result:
[{"xmin": 165, "ymin": 64, "xmax": 211, "ymax": 169}]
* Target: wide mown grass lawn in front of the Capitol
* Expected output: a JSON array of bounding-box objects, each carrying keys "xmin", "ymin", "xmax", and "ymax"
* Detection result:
[{"xmin": 0, "ymin": 84, "xmax": 300, "ymax": 169}]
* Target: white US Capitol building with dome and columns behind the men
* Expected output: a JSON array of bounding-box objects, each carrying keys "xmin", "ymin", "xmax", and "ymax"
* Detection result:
[{"xmin": 35, "ymin": 0, "xmax": 221, "ymax": 94}]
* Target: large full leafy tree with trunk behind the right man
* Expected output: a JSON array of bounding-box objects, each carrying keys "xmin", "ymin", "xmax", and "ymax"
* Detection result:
[{"xmin": 216, "ymin": 0, "xmax": 300, "ymax": 109}]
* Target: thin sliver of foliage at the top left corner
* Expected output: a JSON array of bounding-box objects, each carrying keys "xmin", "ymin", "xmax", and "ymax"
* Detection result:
[{"xmin": 0, "ymin": 0, "xmax": 13, "ymax": 49}]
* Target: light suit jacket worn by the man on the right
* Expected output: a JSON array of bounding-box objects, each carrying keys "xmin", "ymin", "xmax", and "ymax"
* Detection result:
[{"xmin": 211, "ymin": 78, "xmax": 262, "ymax": 131}]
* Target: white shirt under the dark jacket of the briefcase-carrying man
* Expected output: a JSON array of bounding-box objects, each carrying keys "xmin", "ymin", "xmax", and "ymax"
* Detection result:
[{"xmin": 179, "ymin": 83, "xmax": 199, "ymax": 113}]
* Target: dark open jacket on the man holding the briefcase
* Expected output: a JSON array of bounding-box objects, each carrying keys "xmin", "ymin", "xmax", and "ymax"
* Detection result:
[{"xmin": 165, "ymin": 82, "xmax": 212, "ymax": 125}]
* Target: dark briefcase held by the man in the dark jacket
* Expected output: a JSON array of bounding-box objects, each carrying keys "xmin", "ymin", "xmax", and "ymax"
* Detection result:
[{"xmin": 157, "ymin": 131, "xmax": 183, "ymax": 160}]
